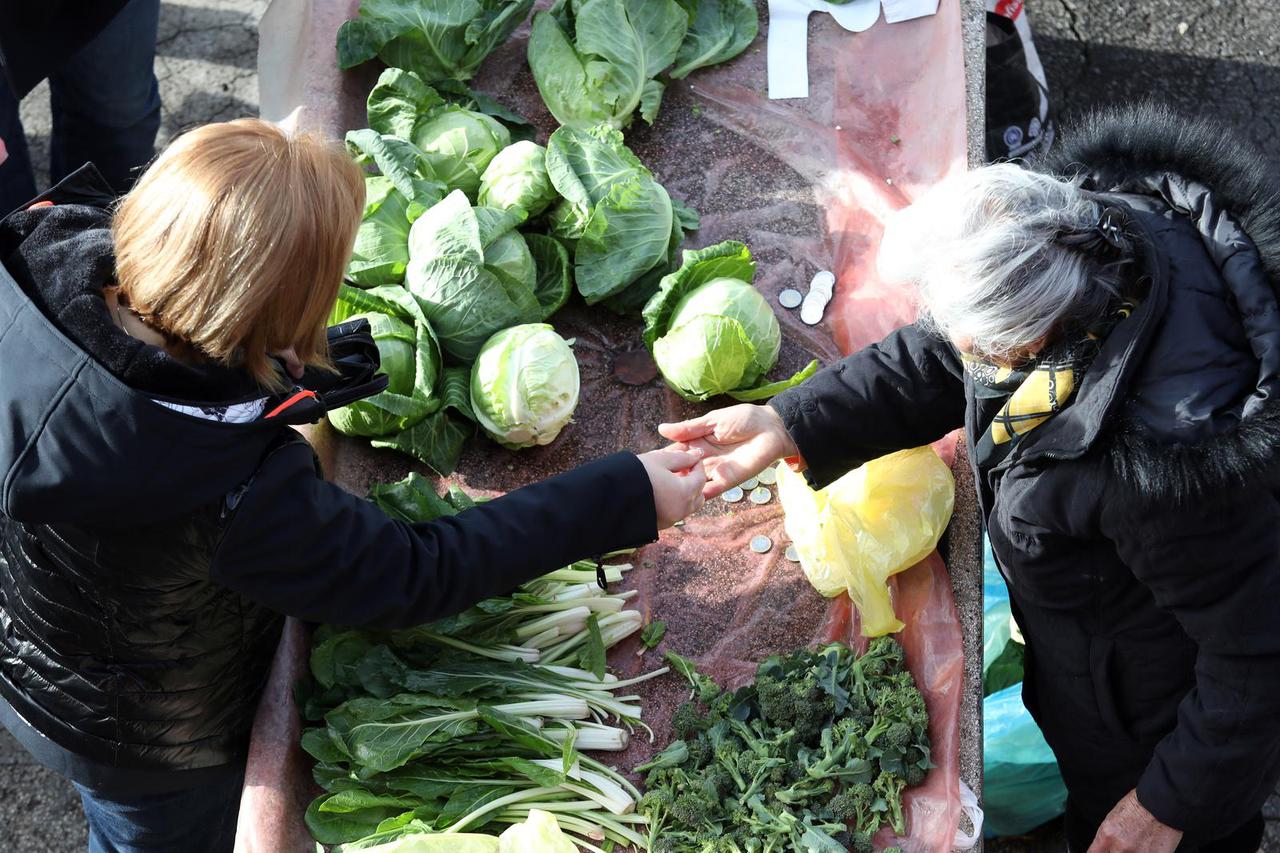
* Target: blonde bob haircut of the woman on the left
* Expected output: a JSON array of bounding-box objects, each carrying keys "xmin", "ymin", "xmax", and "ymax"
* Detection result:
[{"xmin": 111, "ymin": 119, "xmax": 365, "ymax": 389}]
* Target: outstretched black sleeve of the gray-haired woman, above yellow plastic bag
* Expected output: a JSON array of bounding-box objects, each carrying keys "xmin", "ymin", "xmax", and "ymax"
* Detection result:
[{"xmin": 771, "ymin": 324, "xmax": 965, "ymax": 487}]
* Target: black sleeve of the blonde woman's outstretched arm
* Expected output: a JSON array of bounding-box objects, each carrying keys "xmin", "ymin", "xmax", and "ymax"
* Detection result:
[{"xmin": 211, "ymin": 443, "xmax": 658, "ymax": 629}]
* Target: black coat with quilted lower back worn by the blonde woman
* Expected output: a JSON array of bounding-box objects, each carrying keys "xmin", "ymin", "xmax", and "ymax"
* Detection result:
[{"xmin": 0, "ymin": 175, "xmax": 657, "ymax": 794}]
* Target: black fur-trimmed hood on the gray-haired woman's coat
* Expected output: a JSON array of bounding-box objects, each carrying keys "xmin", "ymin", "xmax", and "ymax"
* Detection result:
[{"xmin": 1036, "ymin": 104, "xmax": 1280, "ymax": 503}]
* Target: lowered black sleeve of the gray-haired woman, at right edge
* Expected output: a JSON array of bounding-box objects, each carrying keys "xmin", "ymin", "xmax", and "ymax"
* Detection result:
[{"xmin": 1103, "ymin": 488, "xmax": 1280, "ymax": 843}]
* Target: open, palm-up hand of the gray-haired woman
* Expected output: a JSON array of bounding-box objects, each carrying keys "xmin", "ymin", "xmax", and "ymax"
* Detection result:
[{"xmin": 658, "ymin": 403, "xmax": 800, "ymax": 498}]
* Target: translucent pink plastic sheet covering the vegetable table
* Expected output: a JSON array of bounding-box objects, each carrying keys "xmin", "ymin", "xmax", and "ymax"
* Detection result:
[{"xmin": 239, "ymin": 0, "xmax": 966, "ymax": 853}]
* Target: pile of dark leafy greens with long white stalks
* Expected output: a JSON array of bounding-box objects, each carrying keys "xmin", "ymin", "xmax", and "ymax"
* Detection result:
[{"xmin": 295, "ymin": 522, "xmax": 667, "ymax": 853}]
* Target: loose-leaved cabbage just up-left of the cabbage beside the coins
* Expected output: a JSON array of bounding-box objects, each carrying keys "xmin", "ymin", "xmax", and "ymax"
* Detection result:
[{"xmin": 547, "ymin": 126, "xmax": 696, "ymax": 304}]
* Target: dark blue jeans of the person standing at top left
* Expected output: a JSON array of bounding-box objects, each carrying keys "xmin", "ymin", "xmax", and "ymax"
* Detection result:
[{"xmin": 0, "ymin": 0, "xmax": 160, "ymax": 215}]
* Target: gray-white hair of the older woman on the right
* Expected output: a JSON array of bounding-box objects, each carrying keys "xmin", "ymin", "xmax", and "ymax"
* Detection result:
[{"xmin": 878, "ymin": 164, "xmax": 1120, "ymax": 356}]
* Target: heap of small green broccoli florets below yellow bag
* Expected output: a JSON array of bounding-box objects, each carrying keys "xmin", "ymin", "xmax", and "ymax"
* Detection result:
[{"xmin": 636, "ymin": 637, "xmax": 932, "ymax": 853}]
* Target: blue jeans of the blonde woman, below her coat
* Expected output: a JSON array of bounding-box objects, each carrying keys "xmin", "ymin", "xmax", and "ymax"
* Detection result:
[{"xmin": 76, "ymin": 774, "xmax": 244, "ymax": 853}]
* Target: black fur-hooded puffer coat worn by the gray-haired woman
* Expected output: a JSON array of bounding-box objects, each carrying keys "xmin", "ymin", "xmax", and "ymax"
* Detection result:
[{"xmin": 773, "ymin": 108, "xmax": 1280, "ymax": 849}]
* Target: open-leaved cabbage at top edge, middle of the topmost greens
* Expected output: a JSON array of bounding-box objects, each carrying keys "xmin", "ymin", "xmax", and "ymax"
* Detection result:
[{"xmin": 529, "ymin": 0, "xmax": 689, "ymax": 129}]
